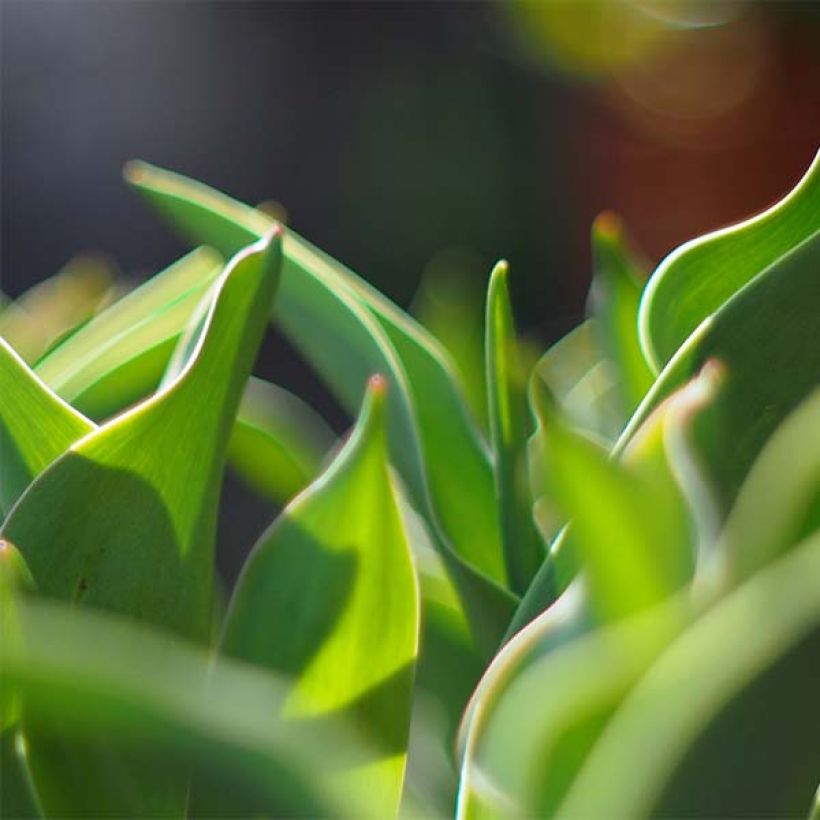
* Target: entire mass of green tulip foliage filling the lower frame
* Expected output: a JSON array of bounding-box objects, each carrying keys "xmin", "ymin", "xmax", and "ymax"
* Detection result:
[{"xmin": 0, "ymin": 152, "xmax": 820, "ymax": 818}]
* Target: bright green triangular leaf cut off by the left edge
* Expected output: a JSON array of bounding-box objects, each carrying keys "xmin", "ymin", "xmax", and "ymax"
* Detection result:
[{"xmin": 0, "ymin": 338, "xmax": 95, "ymax": 513}]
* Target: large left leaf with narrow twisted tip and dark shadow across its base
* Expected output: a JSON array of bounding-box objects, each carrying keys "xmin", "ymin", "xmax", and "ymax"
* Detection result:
[{"xmin": 3, "ymin": 231, "xmax": 280, "ymax": 638}]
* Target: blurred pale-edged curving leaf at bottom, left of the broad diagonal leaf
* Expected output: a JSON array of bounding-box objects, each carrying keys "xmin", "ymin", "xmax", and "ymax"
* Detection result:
[{"xmin": 458, "ymin": 588, "xmax": 687, "ymax": 820}]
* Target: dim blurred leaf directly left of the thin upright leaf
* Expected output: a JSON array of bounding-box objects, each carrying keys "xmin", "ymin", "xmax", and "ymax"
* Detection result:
[{"xmin": 412, "ymin": 254, "xmax": 487, "ymax": 430}]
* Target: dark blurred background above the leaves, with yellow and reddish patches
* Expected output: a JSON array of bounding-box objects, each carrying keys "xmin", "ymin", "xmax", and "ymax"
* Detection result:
[{"xmin": 0, "ymin": 0, "xmax": 820, "ymax": 572}]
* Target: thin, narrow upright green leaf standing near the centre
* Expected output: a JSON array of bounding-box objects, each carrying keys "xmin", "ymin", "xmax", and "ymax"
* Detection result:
[{"xmin": 485, "ymin": 262, "xmax": 543, "ymax": 594}]
